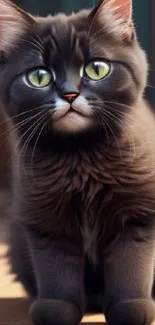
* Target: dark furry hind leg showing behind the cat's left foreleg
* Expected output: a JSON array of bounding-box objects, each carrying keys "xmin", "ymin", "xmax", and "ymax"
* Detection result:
[{"xmin": 8, "ymin": 222, "xmax": 37, "ymax": 299}]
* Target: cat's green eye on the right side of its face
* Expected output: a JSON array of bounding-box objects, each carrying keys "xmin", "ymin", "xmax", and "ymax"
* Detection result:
[{"xmin": 85, "ymin": 61, "xmax": 110, "ymax": 81}]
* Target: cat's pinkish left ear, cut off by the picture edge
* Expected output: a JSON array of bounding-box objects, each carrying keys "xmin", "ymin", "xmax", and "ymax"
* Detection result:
[{"xmin": 0, "ymin": 0, "xmax": 34, "ymax": 52}]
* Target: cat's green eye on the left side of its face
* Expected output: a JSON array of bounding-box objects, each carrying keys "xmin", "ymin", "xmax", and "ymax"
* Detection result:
[{"xmin": 27, "ymin": 69, "xmax": 52, "ymax": 88}]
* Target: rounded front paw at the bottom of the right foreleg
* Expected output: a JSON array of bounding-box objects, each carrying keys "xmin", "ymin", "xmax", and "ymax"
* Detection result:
[{"xmin": 105, "ymin": 299, "xmax": 155, "ymax": 325}]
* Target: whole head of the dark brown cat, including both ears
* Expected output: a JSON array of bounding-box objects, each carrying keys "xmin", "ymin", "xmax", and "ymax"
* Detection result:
[{"xmin": 0, "ymin": 0, "xmax": 147, "ymax": 148}]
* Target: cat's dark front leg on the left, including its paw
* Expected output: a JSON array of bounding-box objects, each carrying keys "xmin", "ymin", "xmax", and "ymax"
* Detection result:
[{"xmin": 27, "ymin": 234, "xmax": 84, "ymax": 325}]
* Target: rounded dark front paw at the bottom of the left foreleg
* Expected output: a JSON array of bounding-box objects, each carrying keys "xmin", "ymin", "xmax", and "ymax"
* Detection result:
[{"xmin": 30, "ymin": 299, "xmax": 82, "ymax": 325}]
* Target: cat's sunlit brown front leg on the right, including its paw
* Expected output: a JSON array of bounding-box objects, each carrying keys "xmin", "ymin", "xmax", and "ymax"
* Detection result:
[{"xmin": 104, "ymin": 219, "xmax": 155, "ymax": 325}]
